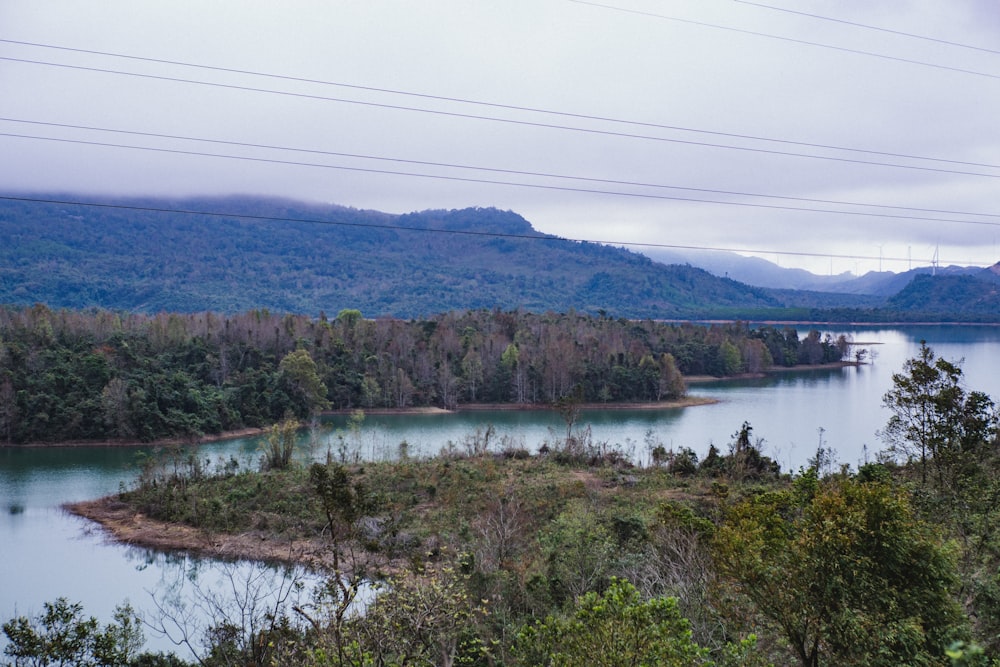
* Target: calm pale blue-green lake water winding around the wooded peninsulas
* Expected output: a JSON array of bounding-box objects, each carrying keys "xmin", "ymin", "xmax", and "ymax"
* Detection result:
[{"xmin": 0, "ymin": 327, "xmax": 1000, "ymax": 650}]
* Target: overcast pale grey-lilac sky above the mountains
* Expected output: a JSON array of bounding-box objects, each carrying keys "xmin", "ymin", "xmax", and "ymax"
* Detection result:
[{"xmin": 0, "ymin": 0, "xmax": 1000, "ymax": 274}]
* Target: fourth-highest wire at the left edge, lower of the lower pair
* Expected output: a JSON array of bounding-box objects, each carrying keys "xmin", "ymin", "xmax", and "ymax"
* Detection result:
[{"xmin": 7, "ymin": 132, "xmax": 1000, "ymax": 227}]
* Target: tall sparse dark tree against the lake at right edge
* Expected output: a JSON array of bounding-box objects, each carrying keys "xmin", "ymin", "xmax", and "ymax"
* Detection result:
[{"xmin": 880, "ymin": 341, "xmax": 997, "ymax": 489}]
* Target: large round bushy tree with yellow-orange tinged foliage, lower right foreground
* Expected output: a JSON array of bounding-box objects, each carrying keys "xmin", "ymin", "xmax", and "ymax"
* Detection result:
[{"xmin": 713, "ymin": 478, "xmax": 964, "ymax": 667}]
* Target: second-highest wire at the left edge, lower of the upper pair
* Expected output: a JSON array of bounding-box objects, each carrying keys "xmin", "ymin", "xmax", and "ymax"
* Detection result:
[{"xmin": 0, "ymin": 55, "xmax": 1000, "ymax": 178}]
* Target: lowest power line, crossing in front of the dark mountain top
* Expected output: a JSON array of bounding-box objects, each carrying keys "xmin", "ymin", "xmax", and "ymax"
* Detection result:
[{"xmin": 0, "ymin": 195, "xmax": 956, "ymax": 265}]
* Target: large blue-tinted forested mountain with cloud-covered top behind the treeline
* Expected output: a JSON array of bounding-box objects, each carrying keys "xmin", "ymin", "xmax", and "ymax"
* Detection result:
[{"xmin": 0, "ymin": 196, "xmax": 784, "ymax": 318}]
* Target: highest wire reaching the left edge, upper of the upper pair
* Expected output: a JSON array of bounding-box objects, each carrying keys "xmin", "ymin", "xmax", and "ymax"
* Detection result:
[{"xmin": 0, "ymin": 38, "xmax": 1000, "ymax": 169}]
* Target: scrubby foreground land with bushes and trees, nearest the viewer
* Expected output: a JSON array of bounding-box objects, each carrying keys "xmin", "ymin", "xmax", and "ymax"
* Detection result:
[{"xmin": 3, "ymin": 345, "xmax": 1000, "ymax": 667}]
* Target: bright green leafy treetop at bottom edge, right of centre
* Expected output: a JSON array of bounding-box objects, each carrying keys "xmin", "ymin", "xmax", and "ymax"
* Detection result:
[{"xmin": 514, "ymin": 579, "xmax": 708, "ymax": 667}]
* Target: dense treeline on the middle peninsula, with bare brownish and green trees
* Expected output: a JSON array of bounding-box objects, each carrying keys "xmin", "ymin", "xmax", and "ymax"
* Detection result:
[{"xmin": 0, "ymin": 305, "xmax": 848, "ymax": 443}]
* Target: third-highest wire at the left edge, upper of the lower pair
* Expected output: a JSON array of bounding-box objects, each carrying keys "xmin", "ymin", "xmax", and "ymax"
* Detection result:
[{"xmin": 0, "ymin": 117, "xmax": 1000, "ymax": 222}]
